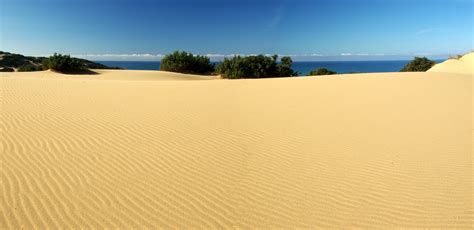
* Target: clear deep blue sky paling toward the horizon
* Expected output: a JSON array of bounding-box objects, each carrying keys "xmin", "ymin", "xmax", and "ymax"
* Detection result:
[{"xmin": 0, "ymin": 0, "xmax": 474, "ymax": 60}]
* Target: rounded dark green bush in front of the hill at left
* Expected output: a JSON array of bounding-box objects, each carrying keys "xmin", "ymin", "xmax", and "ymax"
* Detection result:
[{"xmin": 43, "ymin": 53, "xmax": 87, "ymax": 73}]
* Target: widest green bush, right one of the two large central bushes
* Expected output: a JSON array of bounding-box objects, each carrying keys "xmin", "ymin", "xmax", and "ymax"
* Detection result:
[{"xmin": 216, "ymin": 55, "xmax": 297, "ymax": 79}]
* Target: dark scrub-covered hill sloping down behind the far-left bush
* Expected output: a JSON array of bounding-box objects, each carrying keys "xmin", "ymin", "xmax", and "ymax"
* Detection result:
[{"xmin": 0, "ymin": 51, "xmax": 121, "ymax": 71}]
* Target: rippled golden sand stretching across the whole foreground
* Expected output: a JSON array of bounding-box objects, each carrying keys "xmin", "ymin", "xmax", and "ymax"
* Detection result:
[{"xmin": 0, "ymin": 54, "xmax": 474, "ymax": 229}]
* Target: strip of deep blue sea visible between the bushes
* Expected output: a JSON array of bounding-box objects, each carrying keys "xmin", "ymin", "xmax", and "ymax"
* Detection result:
[{"xmin": 96, "ymin": 60, "xmax": 443, "ymax": 75}]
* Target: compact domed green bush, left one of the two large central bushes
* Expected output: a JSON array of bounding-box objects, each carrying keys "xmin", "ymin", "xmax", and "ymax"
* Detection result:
[{"xmin": 160, "ymin": 51, "xmax": 214, "ymax": 74}]
